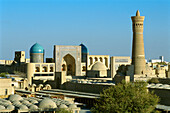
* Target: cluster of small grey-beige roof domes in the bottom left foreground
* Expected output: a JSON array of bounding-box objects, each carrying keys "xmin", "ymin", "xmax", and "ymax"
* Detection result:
[{"xmin": 0, "ymin": 94, "xmax": 77, "ymax": 111}]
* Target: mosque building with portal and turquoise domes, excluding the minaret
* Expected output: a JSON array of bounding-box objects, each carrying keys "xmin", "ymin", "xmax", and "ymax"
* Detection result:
[{"xmin": 0, "ymin": 43, "xmax": 131, "ymax": 85}]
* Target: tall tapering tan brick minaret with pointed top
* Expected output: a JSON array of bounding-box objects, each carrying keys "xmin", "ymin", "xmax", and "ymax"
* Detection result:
[{"xmin": 131, "ymin": 10, "xmax": 145, "ymax": 76}]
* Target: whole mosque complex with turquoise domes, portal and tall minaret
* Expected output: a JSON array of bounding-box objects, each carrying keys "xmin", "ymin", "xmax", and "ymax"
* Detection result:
[{"xmin": 0, "ymin": 11, "xmax": 170, "ymax": 91}]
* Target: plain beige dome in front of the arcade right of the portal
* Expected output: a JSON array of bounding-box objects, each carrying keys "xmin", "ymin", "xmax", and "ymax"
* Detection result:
[{"xmin": 91, "ymin": 62, "xmax": 107, "ymax": 71}]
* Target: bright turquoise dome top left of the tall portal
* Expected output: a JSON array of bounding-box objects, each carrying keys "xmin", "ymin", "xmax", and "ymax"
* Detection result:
[{"xmin": 30, "ymin": 43, "xmax": 44, "ymax": 53}]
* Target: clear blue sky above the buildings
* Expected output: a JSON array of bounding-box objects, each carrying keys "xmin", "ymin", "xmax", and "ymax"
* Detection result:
[{"xmin": 0, "ymin": 0, "xmax": 170, "ymax": 61}]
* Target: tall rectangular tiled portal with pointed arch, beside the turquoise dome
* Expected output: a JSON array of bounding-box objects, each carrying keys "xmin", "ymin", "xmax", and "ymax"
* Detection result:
[{"xmin": 54, "ymin": 45, "xmax": 81, "ymax": 76}]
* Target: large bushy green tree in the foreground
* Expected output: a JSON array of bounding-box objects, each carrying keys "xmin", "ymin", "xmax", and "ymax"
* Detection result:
[{"xmin": 91, "ymin": 81, "xmax": 159, "ymax": 113}]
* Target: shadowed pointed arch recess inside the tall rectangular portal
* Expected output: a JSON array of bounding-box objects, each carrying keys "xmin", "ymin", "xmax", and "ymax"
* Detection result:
[{"xmin": 62, "ymin": 54, "xmax": 76, "ymax": 76}]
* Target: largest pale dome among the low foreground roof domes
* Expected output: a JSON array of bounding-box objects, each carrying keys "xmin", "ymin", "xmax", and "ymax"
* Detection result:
[{"xmin": 39, "ymin": 98, "xmax": 57, "ymax": 109}]
